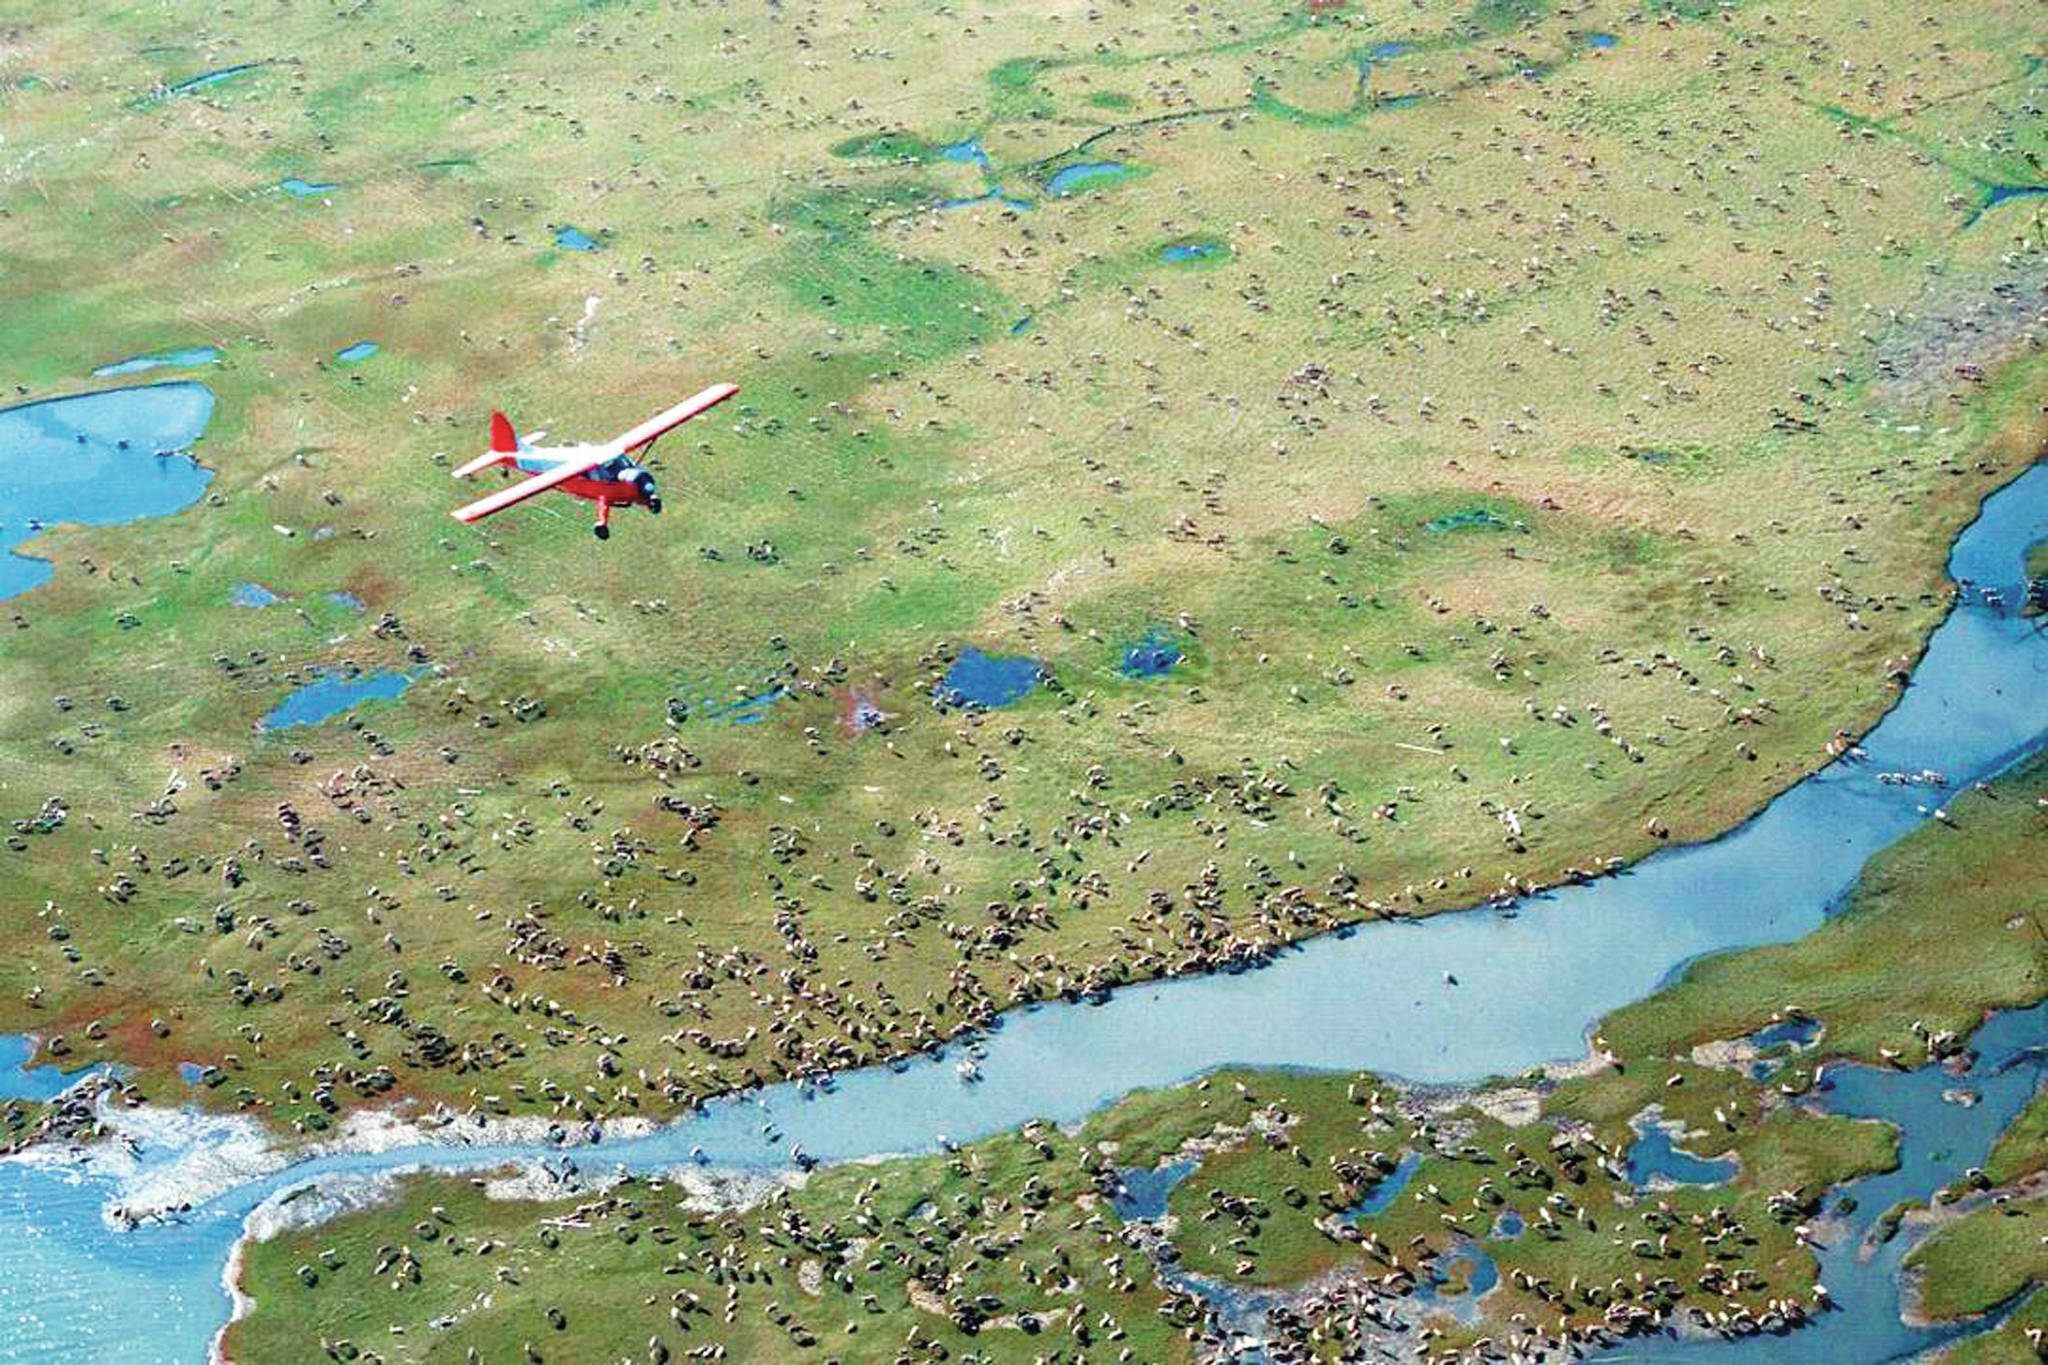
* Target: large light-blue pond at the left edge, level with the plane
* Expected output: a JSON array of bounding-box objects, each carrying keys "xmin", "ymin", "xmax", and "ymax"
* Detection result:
[{"xmin": 0, "ymin": 381, "xmax": 213, "ymax": 600}]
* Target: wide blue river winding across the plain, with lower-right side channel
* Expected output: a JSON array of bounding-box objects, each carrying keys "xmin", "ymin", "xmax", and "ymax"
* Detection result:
[{"xmin": 0, "ymin": 467, "xmax": 2048, "ymax": 1365}]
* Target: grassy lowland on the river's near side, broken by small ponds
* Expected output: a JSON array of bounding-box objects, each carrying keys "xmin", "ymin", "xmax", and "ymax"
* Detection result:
[{"xmin": 231, "ymin": 724, "xmax": 2048, "ymax": 1361}]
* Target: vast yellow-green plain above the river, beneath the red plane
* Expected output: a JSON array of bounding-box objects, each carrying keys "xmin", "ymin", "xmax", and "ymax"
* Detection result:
[{"xmin": 0, "ymin": 2, "xmax": 2044, "ymax": 1128}]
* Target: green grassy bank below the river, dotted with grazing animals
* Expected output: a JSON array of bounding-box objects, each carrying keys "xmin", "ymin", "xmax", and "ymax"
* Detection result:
[{"xmin": 233, "ymin": 724, "xmax": 2044, "ymax": 1361}]
